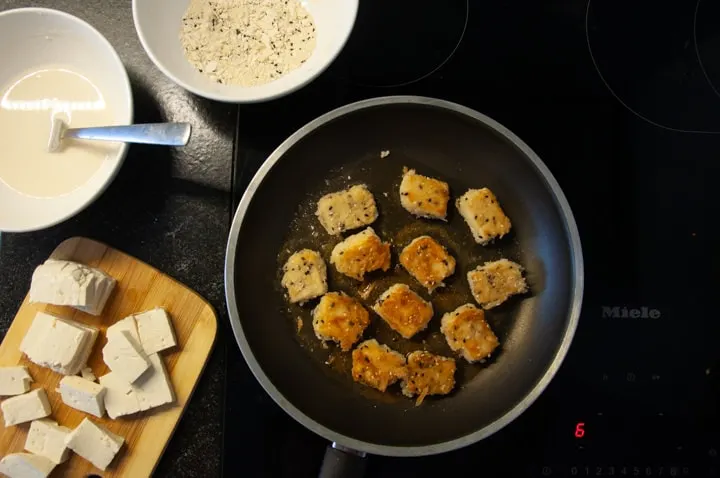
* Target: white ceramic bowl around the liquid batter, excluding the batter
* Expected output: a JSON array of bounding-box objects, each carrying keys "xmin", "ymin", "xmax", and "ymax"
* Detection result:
[{"xmin": 0, "ymin": 8, "xmax": 133, "ymax": 232}]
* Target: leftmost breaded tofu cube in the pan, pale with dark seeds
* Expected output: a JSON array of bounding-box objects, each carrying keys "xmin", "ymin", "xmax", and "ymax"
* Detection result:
[{"xmin": 280, "ymin": 249, "xmax": 327, "ymax": 304}]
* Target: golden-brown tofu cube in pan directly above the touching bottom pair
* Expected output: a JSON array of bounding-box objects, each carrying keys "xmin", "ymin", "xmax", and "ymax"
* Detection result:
[{"xmin": 373, "ymin": 284, "xmax": 433, "ymax": 339}]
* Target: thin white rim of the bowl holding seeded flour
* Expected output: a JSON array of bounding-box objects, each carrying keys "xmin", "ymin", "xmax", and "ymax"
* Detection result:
[{"xmin": 132, "ymin": 0, "xmax": 360, "ymax": 104}]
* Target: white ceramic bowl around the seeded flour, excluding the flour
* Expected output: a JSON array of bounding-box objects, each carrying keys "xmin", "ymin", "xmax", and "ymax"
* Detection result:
[{"xmin": 132, "ymin": 0, "xmax": 358, "ymax": 103}]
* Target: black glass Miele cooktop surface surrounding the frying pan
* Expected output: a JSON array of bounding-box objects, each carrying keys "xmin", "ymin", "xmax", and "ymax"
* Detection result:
[{"xmin": 224, "ymin": 0, "xmax": 720, "ymax": 478}]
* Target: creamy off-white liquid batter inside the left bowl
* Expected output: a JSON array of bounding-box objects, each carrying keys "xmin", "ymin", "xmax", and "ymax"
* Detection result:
[{"xmin": 0, "ymin": 69, "xmax": 118, "ymax": 197}]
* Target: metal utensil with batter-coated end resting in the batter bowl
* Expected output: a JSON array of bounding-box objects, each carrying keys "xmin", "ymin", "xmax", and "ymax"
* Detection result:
[{"xmin": 48, "ymin": 118, "xmax": 192, "ymax": 153}]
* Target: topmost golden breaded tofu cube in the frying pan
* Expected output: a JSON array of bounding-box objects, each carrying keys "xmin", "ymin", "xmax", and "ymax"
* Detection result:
[{"xmin": 400, "ymin": 169, "xmax": 450, "ymax": 221}]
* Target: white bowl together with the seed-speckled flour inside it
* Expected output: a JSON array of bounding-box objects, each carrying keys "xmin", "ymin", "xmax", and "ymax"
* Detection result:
[{"xmin": 132, "ymin": 0, "xmax": 358, "ymax": 103}]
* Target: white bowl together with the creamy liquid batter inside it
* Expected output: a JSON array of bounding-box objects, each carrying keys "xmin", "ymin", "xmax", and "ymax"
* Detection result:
[{"xmin": 0, "ymin": 8, "xmax": 133, "ymax": 232}]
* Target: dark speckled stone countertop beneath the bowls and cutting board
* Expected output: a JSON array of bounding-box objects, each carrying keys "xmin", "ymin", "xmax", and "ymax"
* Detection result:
[{"xmin": 0, "ymin": 0, "xmax": 237, "ymax": 477}]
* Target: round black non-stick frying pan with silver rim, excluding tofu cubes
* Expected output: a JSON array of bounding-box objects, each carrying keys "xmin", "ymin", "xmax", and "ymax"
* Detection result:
[{"xmin": 225, "ymin": 96, "xmax": 583, "ymax": 476}]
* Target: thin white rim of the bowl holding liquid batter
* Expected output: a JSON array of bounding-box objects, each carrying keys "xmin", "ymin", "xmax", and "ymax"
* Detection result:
[{"xmin": 0, "ymin": 7, "xmax": 135, "ymax": 232}]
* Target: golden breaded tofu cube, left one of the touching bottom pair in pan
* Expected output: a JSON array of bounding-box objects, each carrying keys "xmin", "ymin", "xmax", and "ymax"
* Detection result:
[{"xmin": 352, "ymin": 339, "xmax": 406, "ymax": 392}]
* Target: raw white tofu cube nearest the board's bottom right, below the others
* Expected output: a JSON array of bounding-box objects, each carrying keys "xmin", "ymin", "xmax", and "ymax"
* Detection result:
[{"xmin": 67, "ymin": 418, "xmax": 125, "ymax": 470}]
